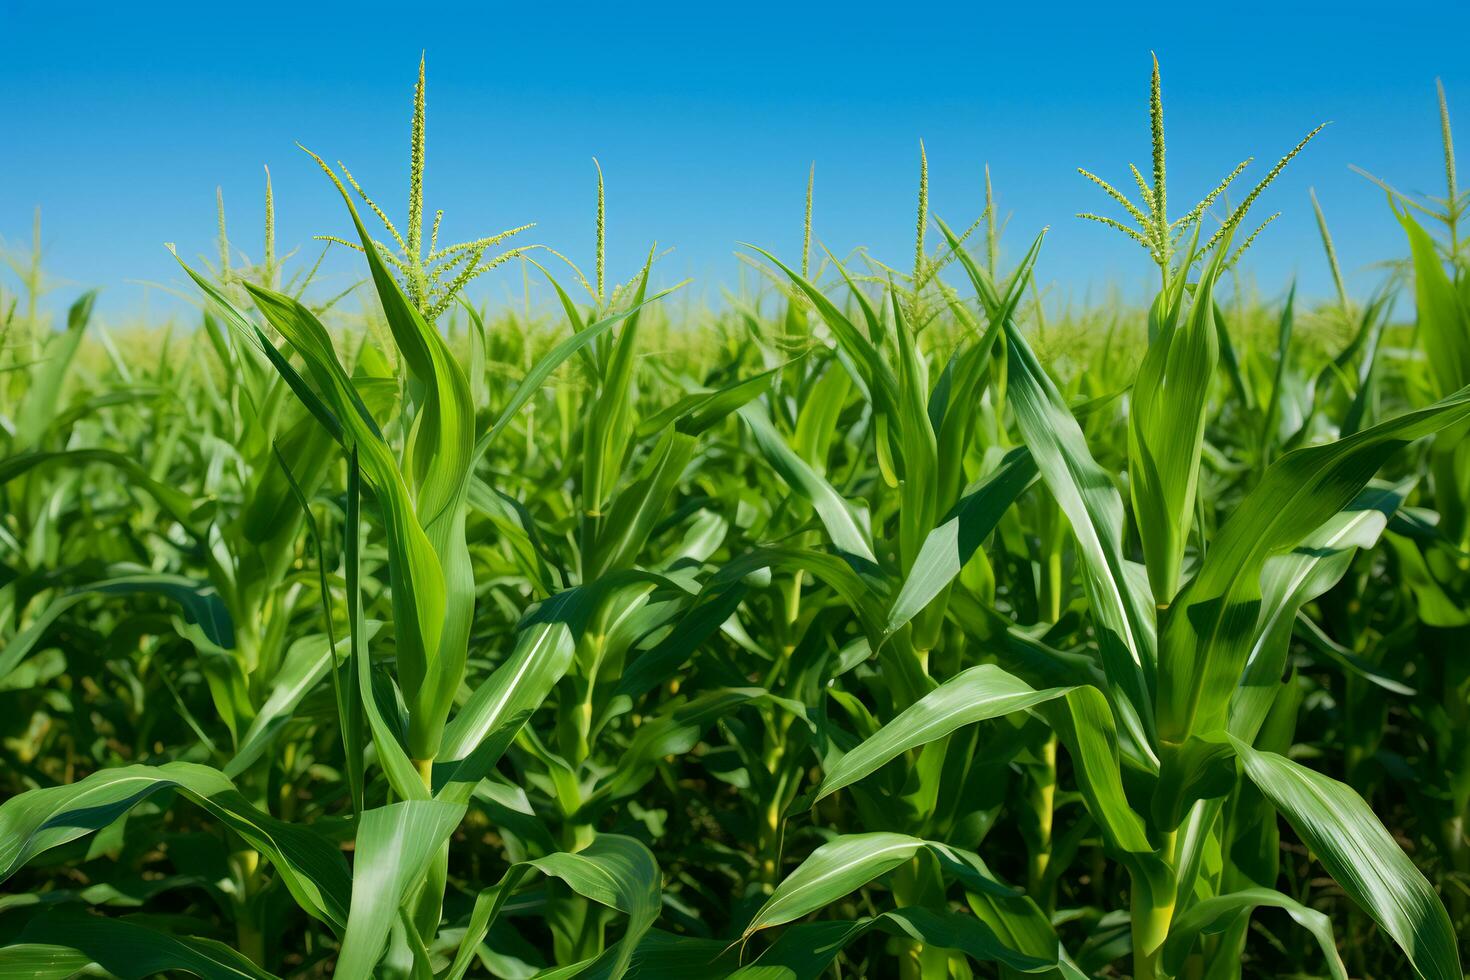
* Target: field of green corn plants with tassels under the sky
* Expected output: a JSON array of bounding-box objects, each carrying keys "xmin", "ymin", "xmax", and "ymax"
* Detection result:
[{"xmin": 0, "ymin": 63, "xmax": 1470, "ymax": 980}]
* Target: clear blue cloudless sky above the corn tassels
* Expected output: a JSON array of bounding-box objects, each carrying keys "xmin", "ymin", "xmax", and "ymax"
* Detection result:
[{"xmin": 0, "ymin": 0, "xmax": 1470, "ymax": 317}]
